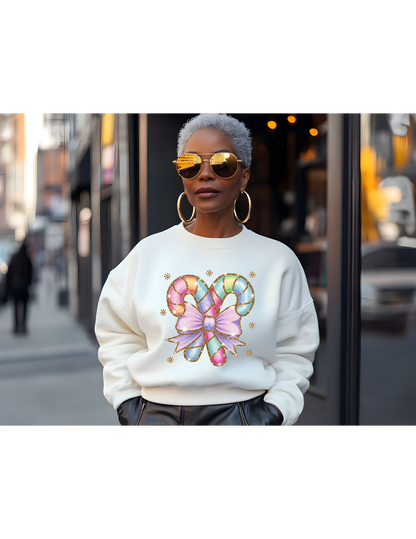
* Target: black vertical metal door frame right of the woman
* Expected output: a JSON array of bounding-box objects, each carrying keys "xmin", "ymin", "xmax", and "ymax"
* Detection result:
[{"xmin": 327, "ymin": 110, "xmax": 361, "ymax": 429}]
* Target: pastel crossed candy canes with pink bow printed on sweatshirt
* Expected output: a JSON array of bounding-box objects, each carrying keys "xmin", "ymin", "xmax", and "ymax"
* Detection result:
[{"xmin": 166, "ymin": 273, "xmax": 255, "ymax": 367}]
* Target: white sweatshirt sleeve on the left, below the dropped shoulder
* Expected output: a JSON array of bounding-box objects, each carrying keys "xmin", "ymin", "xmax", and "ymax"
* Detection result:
[{"xmin": 95, "ymin": 276, "xmax": 147, "ymax": 410}]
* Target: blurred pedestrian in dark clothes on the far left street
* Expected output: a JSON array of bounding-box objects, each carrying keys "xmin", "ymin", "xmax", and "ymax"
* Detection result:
[{"xmin": 7, "ymin": 240, "xmax": 33, "ymax": 333}]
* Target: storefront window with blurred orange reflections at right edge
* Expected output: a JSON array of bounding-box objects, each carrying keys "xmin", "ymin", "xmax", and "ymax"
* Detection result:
[{"xmin": 360, "ymin": 110, "xmax": 416, "ymax": 429}]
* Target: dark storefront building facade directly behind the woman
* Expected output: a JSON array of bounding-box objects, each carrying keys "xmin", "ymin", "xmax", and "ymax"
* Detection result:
[{"xmin": 67, "ymin": 110, "xmax": 416, "ymax": 429}]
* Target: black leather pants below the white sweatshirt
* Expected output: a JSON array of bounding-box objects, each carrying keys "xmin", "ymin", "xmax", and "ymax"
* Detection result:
[{"xmin": 117, "ymin": 395, "xmax": 283, "ymax": 430}]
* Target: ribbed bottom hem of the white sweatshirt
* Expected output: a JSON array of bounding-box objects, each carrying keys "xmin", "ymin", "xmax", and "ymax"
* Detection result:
[{"xmin": 142, "ymin": 386, "xmax": 266, "ymax": 406}]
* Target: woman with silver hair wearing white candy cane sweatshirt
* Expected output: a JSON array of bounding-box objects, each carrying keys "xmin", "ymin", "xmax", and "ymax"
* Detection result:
[{"xmin": 96, "ymin": 110, "xmax": 319, "ymax": 429}]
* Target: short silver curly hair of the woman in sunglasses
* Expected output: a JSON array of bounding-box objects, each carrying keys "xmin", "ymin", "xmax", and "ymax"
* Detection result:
[{"xmin": 178, "ymin": 110, "xmax": 253, "ymax": 168}]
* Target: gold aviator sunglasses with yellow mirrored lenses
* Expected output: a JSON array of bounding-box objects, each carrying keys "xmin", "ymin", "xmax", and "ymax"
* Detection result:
[{"xmin": 173, "ymin": 153, "xmax": 243, "ymax": 180}]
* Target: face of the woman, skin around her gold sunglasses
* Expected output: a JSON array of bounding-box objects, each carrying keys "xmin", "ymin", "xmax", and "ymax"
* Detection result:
[{"xmin": 183, "ymin": 129, "xmax": 250, "ymax": 217}]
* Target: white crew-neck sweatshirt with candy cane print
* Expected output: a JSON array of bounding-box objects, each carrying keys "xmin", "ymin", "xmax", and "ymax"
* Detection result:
[{"xmin": 95, "ymin": 223, "xmax": 319, "ymax": 429}]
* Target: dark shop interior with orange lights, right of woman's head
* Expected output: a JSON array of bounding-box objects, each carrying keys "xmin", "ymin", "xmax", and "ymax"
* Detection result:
[{"xmin": 228, "ymin": 110, "xmax": 328, "ymax": 333}]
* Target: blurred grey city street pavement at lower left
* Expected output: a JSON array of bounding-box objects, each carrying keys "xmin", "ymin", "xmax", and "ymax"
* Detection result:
[{"xmin": 0, "ymin": 267, "xmax": 120, "ymax": 429}]
